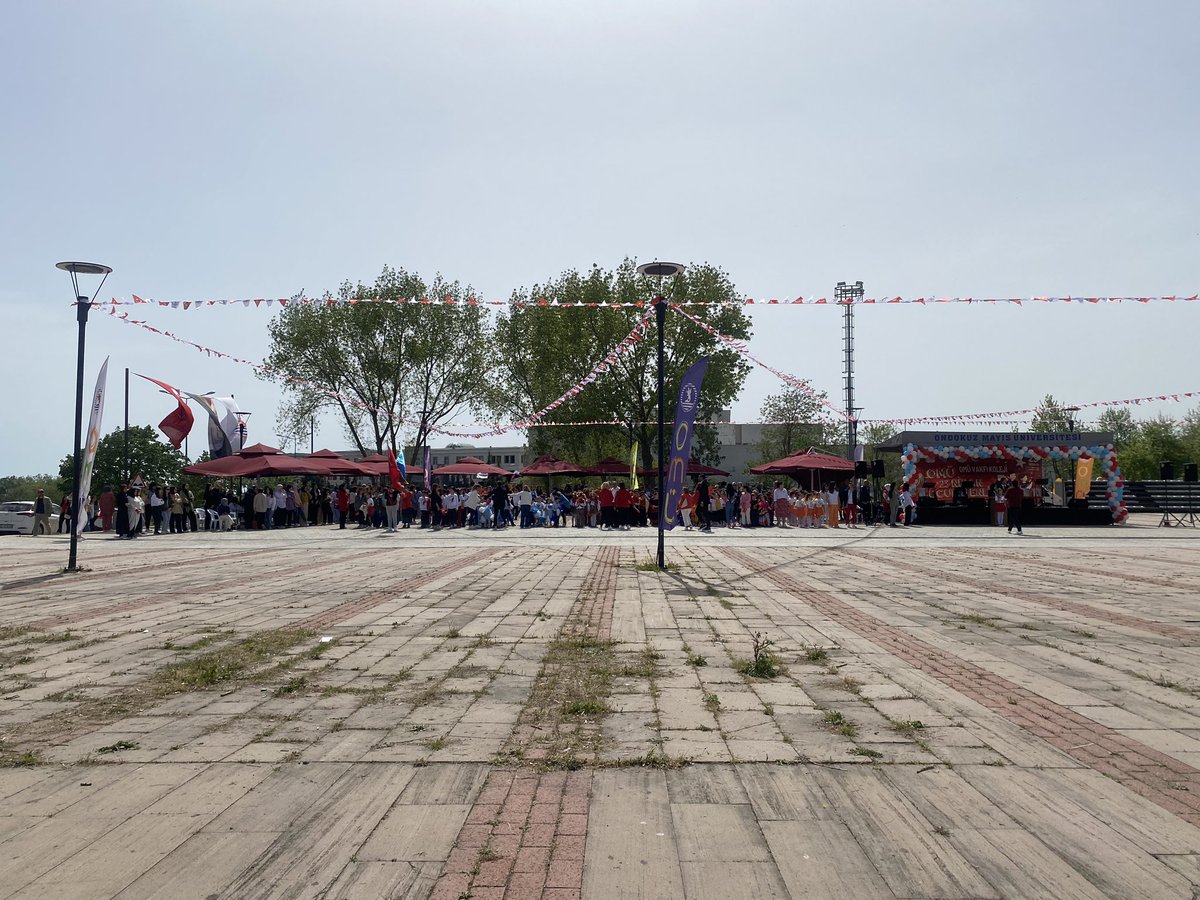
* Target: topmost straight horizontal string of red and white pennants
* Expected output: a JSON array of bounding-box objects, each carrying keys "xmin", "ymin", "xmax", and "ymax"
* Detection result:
[{"xmin": 92, "ymin": 294, "xmax": 1200, "ymax": 310}]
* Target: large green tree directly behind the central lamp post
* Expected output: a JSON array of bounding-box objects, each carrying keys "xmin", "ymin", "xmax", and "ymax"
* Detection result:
[{"xmin": 496, "ymin": 259, "xmax": 750, "ymax": 466}]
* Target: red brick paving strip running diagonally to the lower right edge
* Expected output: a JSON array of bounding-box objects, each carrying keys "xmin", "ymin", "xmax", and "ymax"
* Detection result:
[{"xmin": 721, "ymin": 548, "xmax": 1200, "ymax": 826}]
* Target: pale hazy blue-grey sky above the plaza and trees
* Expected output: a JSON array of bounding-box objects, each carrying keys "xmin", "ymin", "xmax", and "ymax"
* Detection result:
[{"xmin": 0, "ymin": 0, "xmax": 1200, "ymax": 474}]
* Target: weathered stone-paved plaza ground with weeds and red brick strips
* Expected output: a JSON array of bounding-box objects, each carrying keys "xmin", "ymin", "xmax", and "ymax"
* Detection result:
[{"xmin": 0, "ymin": 517, "xmax": 1200, "ymax": 900}]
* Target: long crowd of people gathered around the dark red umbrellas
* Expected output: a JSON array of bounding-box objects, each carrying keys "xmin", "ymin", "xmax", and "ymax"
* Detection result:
[{"xmin": 44, "ymin": 475, "xmax": 945, "ymax": 540}]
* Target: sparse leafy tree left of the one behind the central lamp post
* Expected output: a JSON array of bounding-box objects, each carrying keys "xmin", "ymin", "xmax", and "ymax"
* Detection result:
[{"xmin": 263, "ymin": 268, "xmax": 493, "ymax": 460}]
